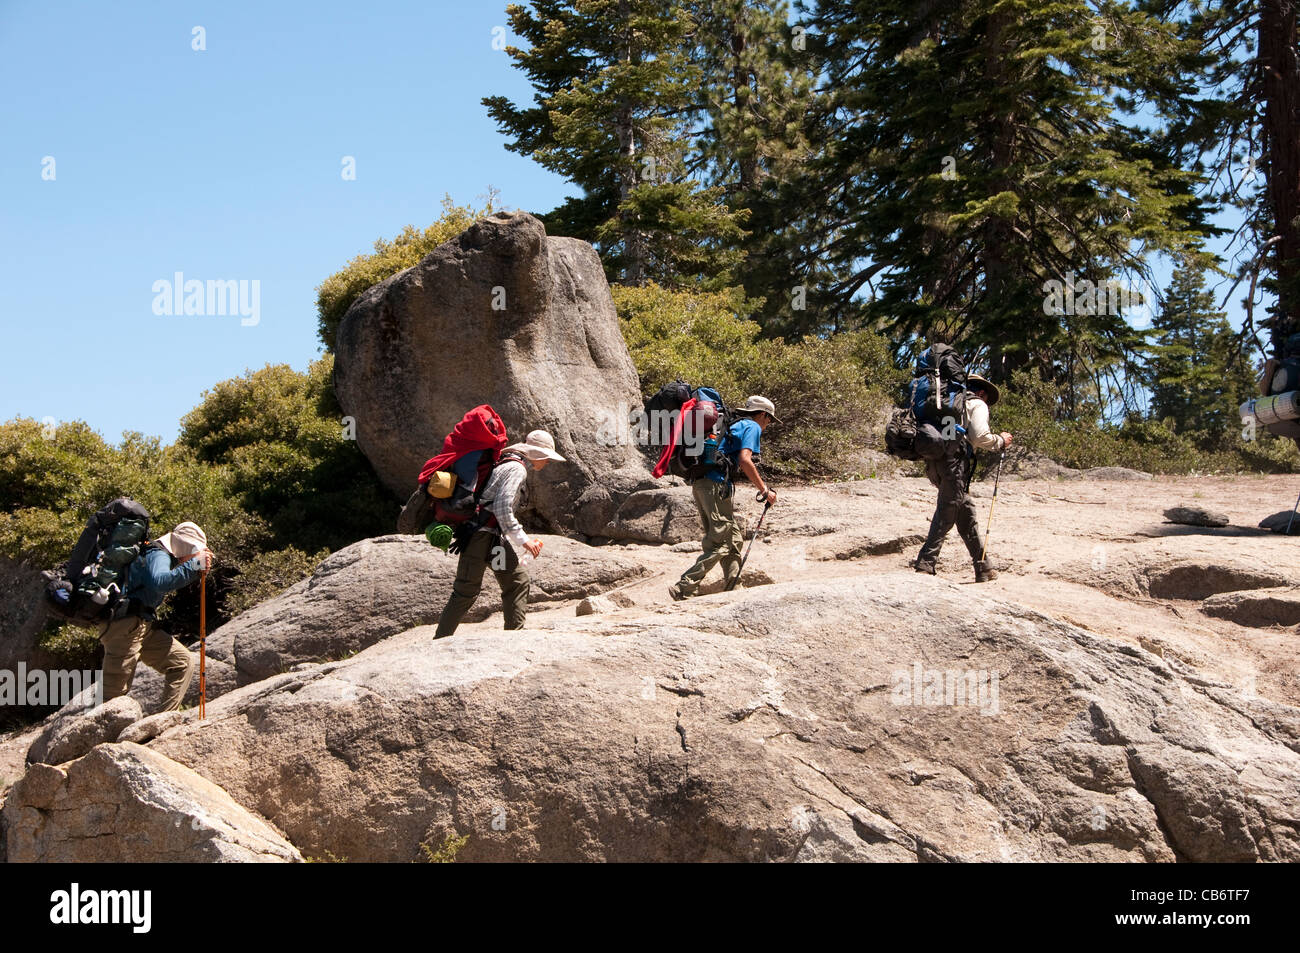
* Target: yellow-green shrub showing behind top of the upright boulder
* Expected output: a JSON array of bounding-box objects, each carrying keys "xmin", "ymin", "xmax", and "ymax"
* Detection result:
[{"xmin": 316, "ymin": 194, "xmax": 495, "ymax": 351}]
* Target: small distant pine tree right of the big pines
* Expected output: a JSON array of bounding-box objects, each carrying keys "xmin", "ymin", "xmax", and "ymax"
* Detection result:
[{"xmin": 1148, "ymin": 257, "xmax": 1253, "ymax": 446}]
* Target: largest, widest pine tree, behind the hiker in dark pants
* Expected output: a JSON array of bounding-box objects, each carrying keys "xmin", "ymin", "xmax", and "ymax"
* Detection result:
[{"xmin": 810, "ymin": 0, "xmax": 1201, "ymax": 389}]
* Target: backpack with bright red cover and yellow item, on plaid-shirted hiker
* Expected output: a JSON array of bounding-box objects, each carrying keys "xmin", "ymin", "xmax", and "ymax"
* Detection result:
[{"xmin": 398, "ymin": 404, "xmax": 507, "ymax": 536}]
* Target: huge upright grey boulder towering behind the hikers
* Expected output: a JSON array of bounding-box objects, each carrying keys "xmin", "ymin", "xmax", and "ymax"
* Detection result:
[{"xmin": 334, "ymin": 212, "xmax": 651, "ymax": 536}]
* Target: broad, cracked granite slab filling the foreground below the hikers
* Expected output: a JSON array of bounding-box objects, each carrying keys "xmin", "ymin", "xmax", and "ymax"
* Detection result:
[{"xmin": 142, "ymin": 572, "xmax": 1300, "ymax": 861}]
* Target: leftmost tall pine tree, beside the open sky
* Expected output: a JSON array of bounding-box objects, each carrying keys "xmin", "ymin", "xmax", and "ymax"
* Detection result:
[{"xmin": 484, "ymin": 0, "xmax": 745, "ymax": 286}]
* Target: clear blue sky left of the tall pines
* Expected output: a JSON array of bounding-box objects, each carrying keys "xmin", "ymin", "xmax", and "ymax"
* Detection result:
[{"xmin": 0, "ymin": 0, "xmax": 567, "ymax": 441}]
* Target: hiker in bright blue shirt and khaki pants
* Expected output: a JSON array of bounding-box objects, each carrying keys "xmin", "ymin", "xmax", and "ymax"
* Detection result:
[{"xmin": 668, "ymin": 395, "xmax": 781, "ymax": 601}]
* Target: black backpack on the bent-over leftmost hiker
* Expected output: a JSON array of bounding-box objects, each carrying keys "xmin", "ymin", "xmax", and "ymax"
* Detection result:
[{"xmin": 43, "ymin": 497, "xmax": 150, "ymax": 628}]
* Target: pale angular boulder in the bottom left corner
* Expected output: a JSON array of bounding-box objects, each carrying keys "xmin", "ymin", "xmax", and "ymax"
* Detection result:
[{"xmin": 4, "ymin": 744, "xmax": 302, "ymax": 863}]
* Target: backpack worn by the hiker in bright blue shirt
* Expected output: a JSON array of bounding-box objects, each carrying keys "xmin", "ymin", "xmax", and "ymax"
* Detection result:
[{"xmin": 645, "ymin": 380, "xmax": 736, "ymax": 481}]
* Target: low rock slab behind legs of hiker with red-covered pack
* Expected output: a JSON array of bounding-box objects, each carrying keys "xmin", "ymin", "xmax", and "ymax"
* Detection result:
[{"xmin": 208, "ymin": 536, "xmax": 645, "ymax": 698}]
